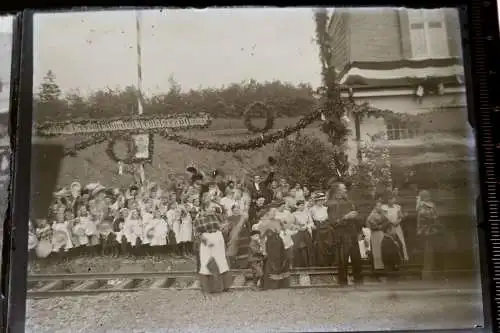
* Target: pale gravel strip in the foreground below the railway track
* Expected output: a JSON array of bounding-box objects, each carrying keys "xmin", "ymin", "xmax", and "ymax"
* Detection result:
[{"xmin": 26, "ymin": 282, "xmax": 483, "ymax": 333}]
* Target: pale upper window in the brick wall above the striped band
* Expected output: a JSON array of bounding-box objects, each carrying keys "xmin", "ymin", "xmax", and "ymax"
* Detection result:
[{"xmin": 408, "ymin": 9, "xmax": 450, "ymax": 59}]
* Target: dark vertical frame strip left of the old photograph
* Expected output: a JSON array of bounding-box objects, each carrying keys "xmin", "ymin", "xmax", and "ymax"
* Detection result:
[{"xmin": 2, "ymin": 10, "xmax": 34, "ymax": 333}]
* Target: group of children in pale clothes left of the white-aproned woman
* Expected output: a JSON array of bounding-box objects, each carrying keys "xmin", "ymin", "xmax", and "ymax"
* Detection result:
[{"xmin": 29, "ymin": 182, "xmax": 199, "ymax": 258}]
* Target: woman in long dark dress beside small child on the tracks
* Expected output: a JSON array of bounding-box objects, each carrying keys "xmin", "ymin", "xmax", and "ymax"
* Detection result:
[{"xmin": 263, "ymin": 220, "xmax": 290, "ymax": 289}]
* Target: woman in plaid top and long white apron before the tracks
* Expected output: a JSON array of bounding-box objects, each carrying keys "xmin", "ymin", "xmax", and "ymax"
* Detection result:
[{"xmin": 194, "ymin": 203, "xmax": 232, "ymax": 293}]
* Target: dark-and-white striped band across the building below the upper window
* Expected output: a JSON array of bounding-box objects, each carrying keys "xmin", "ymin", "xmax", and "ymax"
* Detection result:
[{"xmin": 339, "ymin": 58, "xmax": 464, "ymax": 88}]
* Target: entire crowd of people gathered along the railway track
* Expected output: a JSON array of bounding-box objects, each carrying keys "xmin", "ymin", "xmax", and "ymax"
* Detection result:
[{"xmin": 29, "ymin": 167, "xmax": 441, "ymax": 291}]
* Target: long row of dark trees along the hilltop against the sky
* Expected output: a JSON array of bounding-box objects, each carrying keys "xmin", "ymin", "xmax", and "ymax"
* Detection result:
[{"xmin": 35, "ymin": 72, "xmax": 315, "ymax": 121}]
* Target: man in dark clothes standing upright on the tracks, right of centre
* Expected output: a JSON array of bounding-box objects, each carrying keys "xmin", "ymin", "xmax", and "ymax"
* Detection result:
[{"xmin": 327, "ymin": 182, "xmax": 363, "ymax": 286}]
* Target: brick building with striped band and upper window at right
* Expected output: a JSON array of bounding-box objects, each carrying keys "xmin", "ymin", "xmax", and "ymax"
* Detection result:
[{"xmin": 328, "ymin": 8, "xmax": 477, "ymax": 267}]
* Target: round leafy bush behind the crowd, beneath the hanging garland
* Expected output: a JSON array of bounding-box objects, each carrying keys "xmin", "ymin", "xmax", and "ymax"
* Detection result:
[{"xmin": 276, "ymin": 134, "xmax": 336, "ymax": 190}]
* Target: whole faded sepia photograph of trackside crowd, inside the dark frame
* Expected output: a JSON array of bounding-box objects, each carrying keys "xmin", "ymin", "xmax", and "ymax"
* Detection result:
[{"xmin": 25, "ymin": 7, "xmax": 484, "ymax": 333}]
